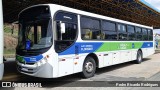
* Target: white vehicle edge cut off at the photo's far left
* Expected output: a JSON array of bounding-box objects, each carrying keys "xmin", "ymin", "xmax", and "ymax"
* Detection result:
[{"xmin": 0, "ymin": 0, "xmax": 4, "ymax": 80}]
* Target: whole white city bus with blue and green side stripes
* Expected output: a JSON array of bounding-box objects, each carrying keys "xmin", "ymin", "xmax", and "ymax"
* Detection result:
[{"xmin": 16, "ymin": 4, "xmax": 154, "ymax": 78}]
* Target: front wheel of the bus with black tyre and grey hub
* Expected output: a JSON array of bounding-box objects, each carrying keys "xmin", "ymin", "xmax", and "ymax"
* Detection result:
[{"xmin": 82, "ymin": 57, "xmax": 96, "ymax": 78}]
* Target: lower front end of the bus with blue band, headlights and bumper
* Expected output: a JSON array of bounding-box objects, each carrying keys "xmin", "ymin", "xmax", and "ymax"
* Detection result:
[{"xmin": 16, "ymin": 47, "xmax": 58, "ymax": 78}]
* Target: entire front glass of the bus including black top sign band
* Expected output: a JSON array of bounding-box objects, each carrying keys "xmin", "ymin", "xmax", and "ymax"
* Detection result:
[{"xmin": 17, "ymin": 5, "xmax": 52, "ymax": 50}]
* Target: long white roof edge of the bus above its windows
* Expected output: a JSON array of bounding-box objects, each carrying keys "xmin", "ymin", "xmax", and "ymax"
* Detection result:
[{"xmin": 19, "ymin": 4, "xmax": 153, "ymax": 29}]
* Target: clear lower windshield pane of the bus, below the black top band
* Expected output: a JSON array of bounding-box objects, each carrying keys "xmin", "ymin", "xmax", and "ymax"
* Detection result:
[{"xmin": 18, "ymin": 19, "xmax": 52, "ymax": 50}]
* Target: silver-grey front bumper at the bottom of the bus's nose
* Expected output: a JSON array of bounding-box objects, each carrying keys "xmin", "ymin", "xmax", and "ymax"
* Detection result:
[{"xmin": 17, "ymin": 63, "xmax": 53, "ymax": 78}]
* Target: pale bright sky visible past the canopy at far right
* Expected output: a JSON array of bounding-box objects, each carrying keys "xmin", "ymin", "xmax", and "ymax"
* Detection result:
[{"xmin": 140, "ymin": 0, "xmax": 160, "ymax": 34}]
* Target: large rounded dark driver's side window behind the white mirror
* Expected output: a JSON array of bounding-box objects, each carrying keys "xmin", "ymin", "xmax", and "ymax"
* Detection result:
[{"xmin": 54, "ymin": 12, "xmax": 78, "ymax": 53}]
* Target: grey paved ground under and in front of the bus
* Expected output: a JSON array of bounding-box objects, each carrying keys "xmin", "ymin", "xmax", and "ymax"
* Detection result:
[{"xmin": 3, "ymin": 53, "xmax": 160, "ymax": 90}]
